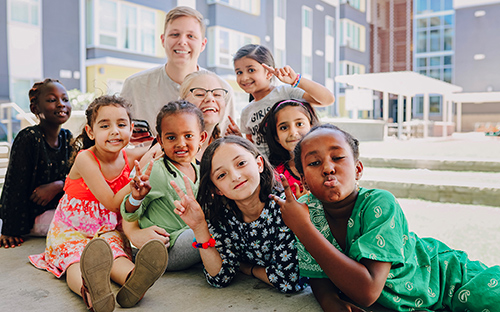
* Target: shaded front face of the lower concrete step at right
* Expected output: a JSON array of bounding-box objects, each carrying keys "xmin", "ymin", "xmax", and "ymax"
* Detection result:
[{"xmin": 359, "ymin": 180, "xmax": 500, "ymax": 207}]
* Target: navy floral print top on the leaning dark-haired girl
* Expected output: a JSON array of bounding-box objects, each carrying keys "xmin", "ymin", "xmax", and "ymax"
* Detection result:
[{"xmin": 205, "ymin": 189, "xmax": 302, "ymax": 293}]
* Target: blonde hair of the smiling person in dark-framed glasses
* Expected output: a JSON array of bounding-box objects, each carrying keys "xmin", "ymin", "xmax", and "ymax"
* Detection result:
[{"xmin": 179, "ymin": 70, "xmax": 236, "ymax": 135}]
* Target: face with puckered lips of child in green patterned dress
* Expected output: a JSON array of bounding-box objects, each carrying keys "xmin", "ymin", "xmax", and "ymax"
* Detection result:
[{"xmin": 301, "ymin": 129, "xmax": 363, "ymax": 203}]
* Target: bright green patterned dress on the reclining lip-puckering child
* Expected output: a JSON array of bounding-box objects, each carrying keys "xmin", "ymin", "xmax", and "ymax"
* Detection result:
[{"xmin": 298, "ymin": 188, "xmax": 500, "ymax": 312}]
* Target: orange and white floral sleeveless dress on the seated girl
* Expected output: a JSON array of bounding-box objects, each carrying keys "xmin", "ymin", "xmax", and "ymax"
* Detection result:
[{"xmin": 29, "ymin": 150, "xmax": 130, "ymax": 278}]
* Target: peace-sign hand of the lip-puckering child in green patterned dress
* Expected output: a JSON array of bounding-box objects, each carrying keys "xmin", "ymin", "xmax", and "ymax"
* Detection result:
[{"xmin": 269, "ymin": 174, "xmax": 311, "ymax": 232}]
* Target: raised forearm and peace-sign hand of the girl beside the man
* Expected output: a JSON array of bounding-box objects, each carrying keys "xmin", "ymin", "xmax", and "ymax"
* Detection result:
[{"xmin": 262, "ymin": 64, "xmax": 335, "ymax": 106}]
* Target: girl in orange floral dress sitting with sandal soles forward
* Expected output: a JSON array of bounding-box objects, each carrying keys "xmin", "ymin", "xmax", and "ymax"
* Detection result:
[{"xmin": 30, "ymin": 96, "xmax": 168, "ymax": 312}]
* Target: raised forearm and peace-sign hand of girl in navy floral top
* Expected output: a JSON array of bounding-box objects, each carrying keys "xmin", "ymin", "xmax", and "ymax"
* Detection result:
[{"xmin": 170, "ymin": 176, "xmax": 222, "ymax": 276}]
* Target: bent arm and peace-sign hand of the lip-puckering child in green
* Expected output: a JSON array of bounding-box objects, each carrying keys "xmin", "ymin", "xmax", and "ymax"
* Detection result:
[{"xmin": 270, "ymin": 176, "xmax": 391, "ymax": 307}]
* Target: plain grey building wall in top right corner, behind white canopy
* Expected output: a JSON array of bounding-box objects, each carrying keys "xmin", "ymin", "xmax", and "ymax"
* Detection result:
[{"xmin": 454, "ymin": 1, "xmax": 500, "ymax": 132}]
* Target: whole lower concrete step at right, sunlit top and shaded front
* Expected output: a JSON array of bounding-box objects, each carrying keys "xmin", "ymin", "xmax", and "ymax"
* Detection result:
[{"xmin": 360, "ymin": 167, "xmax": 500, "ymax": 207}]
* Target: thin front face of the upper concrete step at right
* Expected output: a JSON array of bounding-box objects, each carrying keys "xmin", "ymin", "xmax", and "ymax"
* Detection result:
[{"xmin": 360, "ymin": 157, "xmax": 500, "ymax": 172}]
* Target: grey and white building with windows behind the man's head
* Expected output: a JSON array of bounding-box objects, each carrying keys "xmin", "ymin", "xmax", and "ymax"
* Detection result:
[{"xmin": 0, "ymin": 0, "xmax": 340, "ymax": 120}]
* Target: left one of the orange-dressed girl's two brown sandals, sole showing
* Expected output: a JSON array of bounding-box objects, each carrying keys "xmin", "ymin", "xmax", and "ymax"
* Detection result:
[{"xmin": 80, "ymin": 238, "xmax": 115, "ymax": 312}]
